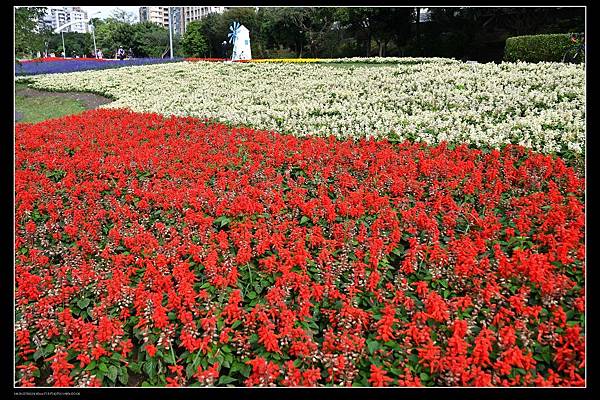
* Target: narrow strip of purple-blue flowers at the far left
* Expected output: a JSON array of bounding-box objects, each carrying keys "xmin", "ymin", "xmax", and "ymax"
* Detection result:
[{"xmin": 15, "ymin": 58, "xmax": 182, "ymax": 75}]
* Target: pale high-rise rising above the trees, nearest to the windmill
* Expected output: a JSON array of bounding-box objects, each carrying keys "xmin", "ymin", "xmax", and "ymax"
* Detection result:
[{"xmin": 140, "ymin": 6, "xmax": 225, "ymax": 35}]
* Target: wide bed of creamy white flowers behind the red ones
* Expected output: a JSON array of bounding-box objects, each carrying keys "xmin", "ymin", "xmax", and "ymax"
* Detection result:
[{"xmin": 19, "ymin": 60, "xmax": 585, "ymax": 153}]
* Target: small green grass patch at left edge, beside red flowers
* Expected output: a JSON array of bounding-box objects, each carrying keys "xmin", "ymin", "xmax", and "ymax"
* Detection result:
[{"xmin": 15, "ymin": 83, "xmax": 86, "ymax": 122}]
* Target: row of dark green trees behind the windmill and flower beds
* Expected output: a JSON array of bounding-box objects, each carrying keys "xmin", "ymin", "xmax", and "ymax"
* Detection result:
[{"xmin": 16, "ymin": 7, "xmax": 585, "ymax": 61}]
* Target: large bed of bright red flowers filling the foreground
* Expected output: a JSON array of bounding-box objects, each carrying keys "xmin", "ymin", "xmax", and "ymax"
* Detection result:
[{"xmin": 15, "ymin": 110, "xmax": 585, "ymax": 386}]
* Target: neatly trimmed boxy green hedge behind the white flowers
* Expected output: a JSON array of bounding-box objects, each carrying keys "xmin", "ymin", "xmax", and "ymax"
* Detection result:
[{"xmin": 504, "ymin": 33, "xmax": 584, "ymax": 62}]
